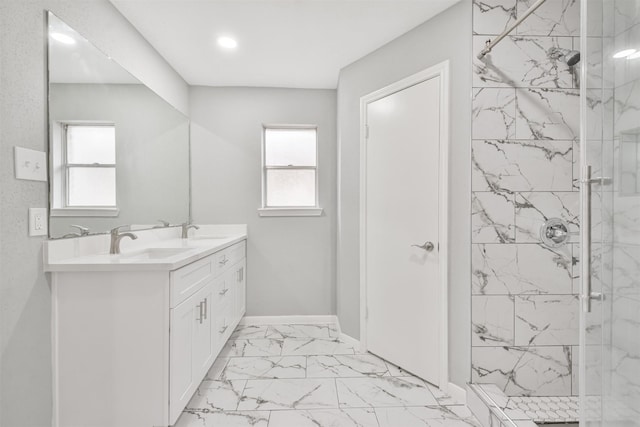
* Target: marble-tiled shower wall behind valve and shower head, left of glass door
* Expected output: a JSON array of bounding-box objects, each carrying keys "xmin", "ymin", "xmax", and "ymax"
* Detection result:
[{"xmin": 471, "ymin": 0, "xmax": 580, "ymax": 396}]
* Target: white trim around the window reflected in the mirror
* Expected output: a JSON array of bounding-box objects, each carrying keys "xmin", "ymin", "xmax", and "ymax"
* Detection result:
[{"xmin": 50, "ymin": 120, "xmax": 120, "ymax": 217}]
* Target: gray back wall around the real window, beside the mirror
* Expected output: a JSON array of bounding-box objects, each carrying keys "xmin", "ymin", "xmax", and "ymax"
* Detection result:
[{"xmin": 190, "ymin": 87, "xmax": 336, "ymax": 316}]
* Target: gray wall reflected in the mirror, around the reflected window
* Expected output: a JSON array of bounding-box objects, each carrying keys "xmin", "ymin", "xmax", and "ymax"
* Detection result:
[{"xmin": 49, "ymin": 83, "xmax": 189, "ymax": 237}]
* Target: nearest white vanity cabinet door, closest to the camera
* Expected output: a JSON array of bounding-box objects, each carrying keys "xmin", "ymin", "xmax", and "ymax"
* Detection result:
[{"xmin": 169, "ymin": 297, "xmax": 199, "ymax": 421}]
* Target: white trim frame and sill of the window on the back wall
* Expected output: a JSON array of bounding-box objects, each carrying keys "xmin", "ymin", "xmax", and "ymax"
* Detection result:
[{"xmin": 258, "ymin": 123, "xmax": 324, "ymax": 217}]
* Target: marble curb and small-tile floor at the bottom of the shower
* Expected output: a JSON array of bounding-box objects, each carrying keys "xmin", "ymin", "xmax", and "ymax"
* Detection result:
[{"xmin": 467, "ymin": 384, "xmax": 579, "ymax": 427}]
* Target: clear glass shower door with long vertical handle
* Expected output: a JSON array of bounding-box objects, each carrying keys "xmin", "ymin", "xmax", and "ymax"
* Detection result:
[{"xmin": 579, "ymin": 0, "xmax": 640, "ymax": 427}]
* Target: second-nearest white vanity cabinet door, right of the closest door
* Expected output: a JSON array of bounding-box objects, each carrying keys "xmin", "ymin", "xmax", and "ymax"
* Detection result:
[{"xmin": 193, "ymin": 281, "xmax": 214, "ymax": 383}]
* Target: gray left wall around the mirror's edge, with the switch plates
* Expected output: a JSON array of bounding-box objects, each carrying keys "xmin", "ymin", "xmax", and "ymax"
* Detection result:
[{"xmin": 0, "ymin": 0, "xmax": 188, "ymax": 427}]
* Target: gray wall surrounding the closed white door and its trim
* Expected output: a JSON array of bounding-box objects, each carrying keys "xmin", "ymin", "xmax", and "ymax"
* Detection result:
[{"xmin": 337, "ymin": 0, "xmax": 471, "ymax": 385}]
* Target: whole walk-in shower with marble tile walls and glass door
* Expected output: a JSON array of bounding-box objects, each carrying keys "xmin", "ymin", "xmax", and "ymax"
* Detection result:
[{"xmin": 471, "ymin": 0, "xmax": 640, "ymax": 427}]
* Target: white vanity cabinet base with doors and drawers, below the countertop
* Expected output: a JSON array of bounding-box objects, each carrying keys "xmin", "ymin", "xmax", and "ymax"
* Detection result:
[{"xmin": 52, "ymin": 240, "xmax": 246, "ymax": 427}]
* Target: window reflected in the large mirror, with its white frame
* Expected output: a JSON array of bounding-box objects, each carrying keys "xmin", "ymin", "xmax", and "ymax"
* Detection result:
[{"xmin": 52, "ymin": 123, "xmax": 117, "ymax": 216}]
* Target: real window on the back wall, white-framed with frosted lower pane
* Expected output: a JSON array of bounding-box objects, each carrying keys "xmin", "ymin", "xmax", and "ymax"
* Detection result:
[{"xmin": 260, "ymin": 126, "xmax": 322, "ymax": 216}]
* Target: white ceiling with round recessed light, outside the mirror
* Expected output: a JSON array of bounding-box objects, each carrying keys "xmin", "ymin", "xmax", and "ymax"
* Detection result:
[{"xmin": 111, "ymin": 0, "xmax": 459, "ymax": 88}]
